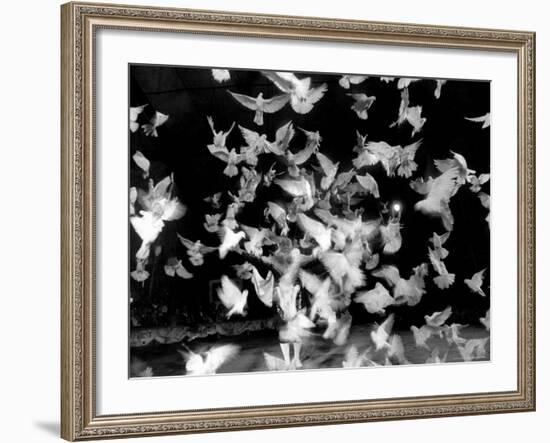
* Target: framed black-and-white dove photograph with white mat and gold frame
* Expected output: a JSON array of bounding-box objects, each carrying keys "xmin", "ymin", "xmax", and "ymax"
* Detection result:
[{"xmin": 61, "ymin": 3, "xmax": 535, "ymax": 441}]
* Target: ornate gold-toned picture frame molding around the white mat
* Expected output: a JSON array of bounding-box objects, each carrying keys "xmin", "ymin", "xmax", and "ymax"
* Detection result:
[{"xmin": 61, "ymin": 2, "xmax": 535, "ymax": 441}]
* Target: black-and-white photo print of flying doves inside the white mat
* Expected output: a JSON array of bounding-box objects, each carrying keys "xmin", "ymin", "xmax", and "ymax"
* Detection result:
[{"xmin": 128, "ymin": 64, "xmax": 491, "ymax": 378}]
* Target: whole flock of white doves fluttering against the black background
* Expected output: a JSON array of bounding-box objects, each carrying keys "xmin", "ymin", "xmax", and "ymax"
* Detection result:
[{"xmin": 130, "ymin": 69, "xmax": 490, "ymax": 374}]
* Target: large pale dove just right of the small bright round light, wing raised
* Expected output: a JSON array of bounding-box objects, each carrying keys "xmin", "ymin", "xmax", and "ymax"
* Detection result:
[{"xmin": 411, "ymin": 167, "xmax": 459, "ymax": 231}]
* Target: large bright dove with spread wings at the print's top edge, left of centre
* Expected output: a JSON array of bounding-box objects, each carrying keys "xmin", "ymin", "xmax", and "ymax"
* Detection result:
[{"xmin": 263, "ymin": 71, "xmax": 327, "ymax": 114}]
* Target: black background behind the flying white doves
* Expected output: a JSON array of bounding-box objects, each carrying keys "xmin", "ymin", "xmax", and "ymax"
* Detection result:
[{"xmin": 129, "ymin": 65, "xmax": 490, "ymax": 327}]
